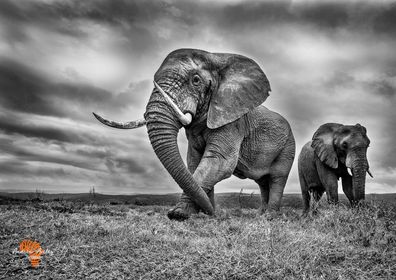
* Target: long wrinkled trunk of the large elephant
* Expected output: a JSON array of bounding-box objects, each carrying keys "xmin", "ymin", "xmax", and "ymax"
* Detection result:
[{"xmin": 145, "ymin": 90, "xmax": 214, "ymax": 215}]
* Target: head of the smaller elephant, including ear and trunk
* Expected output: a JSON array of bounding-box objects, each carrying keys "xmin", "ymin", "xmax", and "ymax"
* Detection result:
[{"xmin": 311, "ymin": 123, "xmax": 372, "ymax": 202}]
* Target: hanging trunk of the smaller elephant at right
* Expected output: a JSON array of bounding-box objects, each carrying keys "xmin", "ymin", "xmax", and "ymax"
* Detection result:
[{"xmin": 352, "ymin": 156, "xmax": 368, "ymax": 203}]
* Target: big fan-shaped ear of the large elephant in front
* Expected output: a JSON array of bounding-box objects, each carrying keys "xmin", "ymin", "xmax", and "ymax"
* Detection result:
[{"xmin": 207, "ymin": 54, "xmax": 271, "ymax": 129}]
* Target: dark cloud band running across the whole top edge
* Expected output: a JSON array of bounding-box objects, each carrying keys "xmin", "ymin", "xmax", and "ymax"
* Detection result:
[{"xmin": 0, "ymin": 0, "xmax": 396, "ymax": 46}]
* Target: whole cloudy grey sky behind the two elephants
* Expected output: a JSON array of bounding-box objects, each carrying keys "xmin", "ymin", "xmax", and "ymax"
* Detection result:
[{"xmin": 0, "ymin": 0, "xmax": 396, "ymax": 193}]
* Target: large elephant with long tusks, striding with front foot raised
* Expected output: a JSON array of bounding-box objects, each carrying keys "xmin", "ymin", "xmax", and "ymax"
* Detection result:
[{"xmin": 95, "ymin": 49, "xmax": 295, "ymax": 220}]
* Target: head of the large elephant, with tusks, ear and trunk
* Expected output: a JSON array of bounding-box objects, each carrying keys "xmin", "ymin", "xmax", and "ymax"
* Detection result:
[{"xmin": 95, "ymin": 49, "xmax": 270, "ymax": 214}]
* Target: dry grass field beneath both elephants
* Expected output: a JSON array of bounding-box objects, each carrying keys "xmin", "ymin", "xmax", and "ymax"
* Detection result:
[{"xmin": 0, "ymin": 194, "xmax": 396, "ymax": 280}]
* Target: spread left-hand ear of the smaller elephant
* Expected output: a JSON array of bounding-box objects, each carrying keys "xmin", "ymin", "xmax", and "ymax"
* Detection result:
[{"xmin": 311, "ymin": 123, "xmax": 342, "ymax": 168}]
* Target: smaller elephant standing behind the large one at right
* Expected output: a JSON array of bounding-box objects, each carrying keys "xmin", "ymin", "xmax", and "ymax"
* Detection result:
[{"xmin": 298, "ymin": 123, "xmax": 373, "ymax": 214}]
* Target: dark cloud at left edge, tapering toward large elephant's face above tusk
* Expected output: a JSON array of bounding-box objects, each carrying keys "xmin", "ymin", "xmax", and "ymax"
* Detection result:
[{"xmin": 0, "ymin": 59, "xmax": 149, "ymax": 120}]
